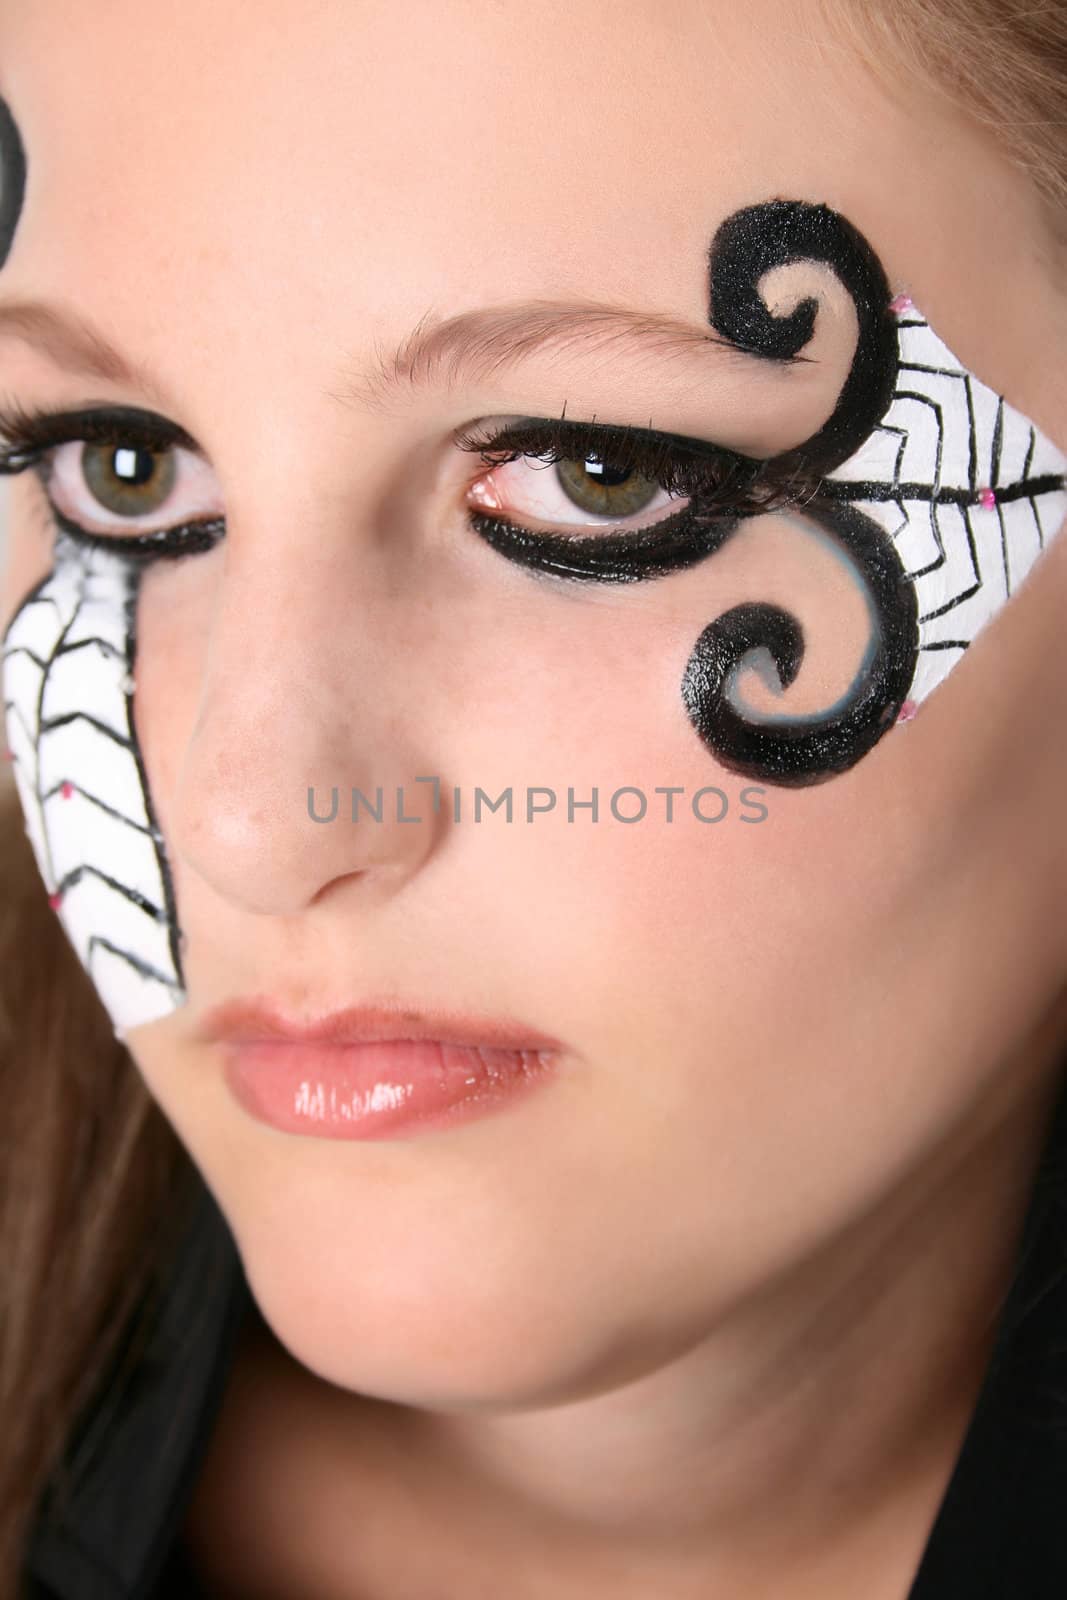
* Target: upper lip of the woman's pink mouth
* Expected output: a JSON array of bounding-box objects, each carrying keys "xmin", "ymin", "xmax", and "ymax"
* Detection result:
[{"xmin": 200, "ymin": 1000, "xmax": 563, "ymax": 1050}]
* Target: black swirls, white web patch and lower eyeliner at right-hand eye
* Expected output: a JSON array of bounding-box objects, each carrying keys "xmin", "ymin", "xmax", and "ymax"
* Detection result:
[{"xmin": 475, "ymin": 198, "xmax": 1067, "ymax": 787}]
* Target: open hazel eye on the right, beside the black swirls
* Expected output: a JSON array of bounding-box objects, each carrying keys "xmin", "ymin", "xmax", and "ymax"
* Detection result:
[{"xmin": 469, "ymin": 454, "xmax": 686, "ymax": 528}]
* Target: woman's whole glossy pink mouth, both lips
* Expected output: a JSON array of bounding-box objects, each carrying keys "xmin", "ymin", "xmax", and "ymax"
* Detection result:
[{"xmin": 200, "ymin": 1000, "xmax": 563, "ymax": 1139}]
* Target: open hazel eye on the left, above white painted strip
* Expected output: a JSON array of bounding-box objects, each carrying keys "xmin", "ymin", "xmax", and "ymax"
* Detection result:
[{"xmin": 38, "ymin": 438, "xmax": 222, "ymax": 534}]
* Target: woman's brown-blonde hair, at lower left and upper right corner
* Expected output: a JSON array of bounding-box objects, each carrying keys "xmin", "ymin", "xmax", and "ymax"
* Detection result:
[{"xmin": 0, "ymin": 0, "xmax": 1067, "ymax": 1595}]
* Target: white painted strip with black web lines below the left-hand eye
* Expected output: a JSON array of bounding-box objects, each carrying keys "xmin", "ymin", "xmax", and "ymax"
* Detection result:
[{"xmin": 3, "ymin": 531, "xmax": 186, "ymax": 1032}]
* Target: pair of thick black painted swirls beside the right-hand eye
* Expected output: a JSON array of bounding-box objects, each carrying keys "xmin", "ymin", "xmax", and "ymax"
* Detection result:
[{"xmin": 681, "ymin": 200, "xmax": 918, "ymax": 786}]
